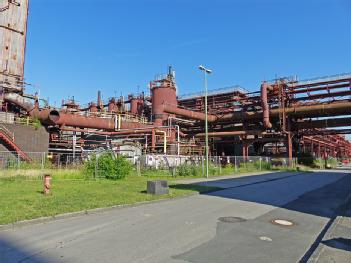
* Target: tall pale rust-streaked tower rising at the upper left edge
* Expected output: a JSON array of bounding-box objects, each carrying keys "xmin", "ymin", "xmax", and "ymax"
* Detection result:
[{"xmin": 0, "ymin": 0, "xmax": 29, "ymax": 93}]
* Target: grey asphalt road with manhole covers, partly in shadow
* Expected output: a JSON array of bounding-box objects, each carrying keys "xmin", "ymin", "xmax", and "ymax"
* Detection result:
[{"xmin": 0, "ymin": 171, "xmax": 351, "ymax": 263}]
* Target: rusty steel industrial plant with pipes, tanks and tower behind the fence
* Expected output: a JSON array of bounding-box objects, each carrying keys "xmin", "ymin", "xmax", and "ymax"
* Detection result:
[{"xmin": 0, "ymin": 0, "xmax": 351, "ymax": 165}]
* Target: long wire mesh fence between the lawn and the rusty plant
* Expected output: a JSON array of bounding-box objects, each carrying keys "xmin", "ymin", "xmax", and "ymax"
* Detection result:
[{"xmin": 0, "ymin": 152, "xmax": 350, "ymax": 178}]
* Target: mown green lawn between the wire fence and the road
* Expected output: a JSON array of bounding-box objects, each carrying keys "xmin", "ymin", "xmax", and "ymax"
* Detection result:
[{"xmin": 0, "ymin": 173, "xmax": 218, "ymax": 224}]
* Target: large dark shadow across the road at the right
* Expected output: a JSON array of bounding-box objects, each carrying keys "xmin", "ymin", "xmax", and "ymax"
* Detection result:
[{"xmin": 199, "ymin": 172, "xmax": 351, "ymax": 218}]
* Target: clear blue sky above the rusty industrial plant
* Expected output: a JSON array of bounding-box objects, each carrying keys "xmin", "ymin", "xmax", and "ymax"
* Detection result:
[{"xmin": 25, "ymin": 0, "xmax": 351, "ymax": 105}]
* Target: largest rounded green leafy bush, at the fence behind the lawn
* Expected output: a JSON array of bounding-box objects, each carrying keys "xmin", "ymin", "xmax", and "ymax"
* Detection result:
[{"xmin": 85, "ymin": 152, "xmax": 133, "ymax": 180}]
